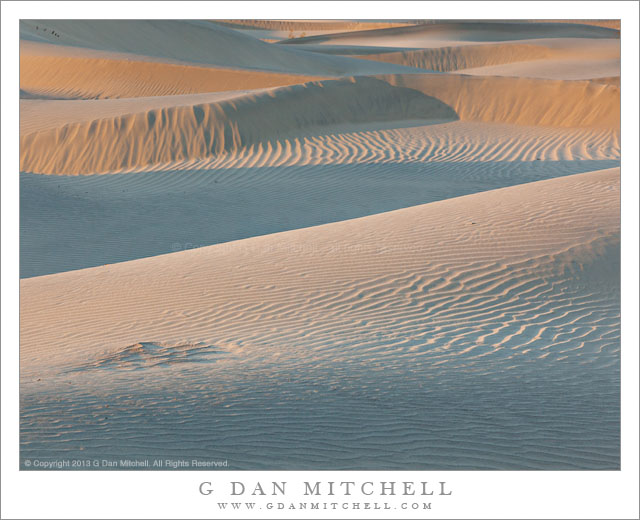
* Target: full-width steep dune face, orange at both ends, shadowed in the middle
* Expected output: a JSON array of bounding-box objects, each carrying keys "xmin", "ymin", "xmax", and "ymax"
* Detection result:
[{"xmin": 20, "ymin": 75, "xmax": 620, "ymax": 175}]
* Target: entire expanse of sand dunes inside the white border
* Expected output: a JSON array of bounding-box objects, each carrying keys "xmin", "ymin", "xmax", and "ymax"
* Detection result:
[{"xmin": 19, "ymin": 20, "xmax": 620, "ymax": 470}]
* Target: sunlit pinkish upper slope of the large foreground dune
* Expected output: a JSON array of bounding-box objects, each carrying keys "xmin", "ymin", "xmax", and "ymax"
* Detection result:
[{"xmin": 20, "ymin": 168, "xmax": 619, "ymax": 377}]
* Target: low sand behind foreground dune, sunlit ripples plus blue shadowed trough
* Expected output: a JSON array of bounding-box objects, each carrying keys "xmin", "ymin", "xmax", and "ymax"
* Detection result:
[{"xmin": 20, "ymin": 121, "xmax": 620, "ymax": 277}]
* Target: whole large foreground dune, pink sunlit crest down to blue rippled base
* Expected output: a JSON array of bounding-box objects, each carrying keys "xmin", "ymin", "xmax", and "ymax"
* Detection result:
[{"xmin": 21, "ymin": 170, "xmax": 619, "ymax": 469}]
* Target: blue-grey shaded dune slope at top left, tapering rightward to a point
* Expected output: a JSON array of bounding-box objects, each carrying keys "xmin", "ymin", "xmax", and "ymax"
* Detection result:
[{"xmin": 20, "ymin": 20, "xmax": 420, "ymax": 76}]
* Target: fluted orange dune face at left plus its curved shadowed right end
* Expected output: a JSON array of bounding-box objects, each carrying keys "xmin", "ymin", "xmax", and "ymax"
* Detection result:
[{"xmin": 20, "ymin": 78, "xmax": 456, "ymax": 175}]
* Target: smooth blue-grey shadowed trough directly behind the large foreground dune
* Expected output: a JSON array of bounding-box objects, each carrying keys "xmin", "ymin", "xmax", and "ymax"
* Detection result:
[{"xmin": 20, "ymin": 159, "xmax": 619, "ymax": 278}]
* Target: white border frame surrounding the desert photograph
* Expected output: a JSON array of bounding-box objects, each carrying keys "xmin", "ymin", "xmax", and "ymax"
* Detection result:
[{"xmin": 1, "ymin": 1, "xmax": 639, "ymax": 518}]
